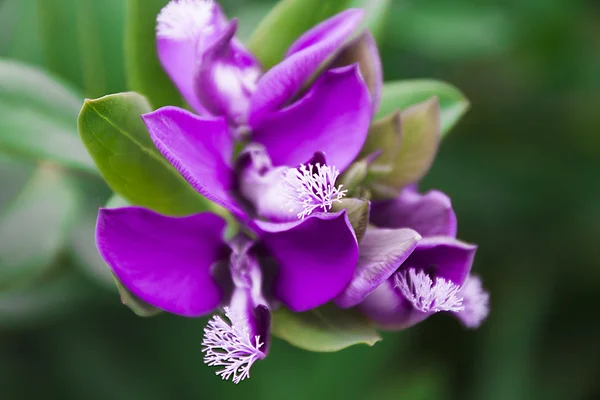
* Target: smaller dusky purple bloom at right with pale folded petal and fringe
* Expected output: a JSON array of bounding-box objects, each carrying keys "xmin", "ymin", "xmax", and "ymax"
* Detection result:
[{"xmin": 336, "ymin": 187, "xmax": 489, "ymax": 330}]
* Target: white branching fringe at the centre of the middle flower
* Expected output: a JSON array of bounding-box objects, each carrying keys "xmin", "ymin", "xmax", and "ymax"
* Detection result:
[{"xmin": 283, "ymin": 163, "xmax": 348, "ymax": 219}]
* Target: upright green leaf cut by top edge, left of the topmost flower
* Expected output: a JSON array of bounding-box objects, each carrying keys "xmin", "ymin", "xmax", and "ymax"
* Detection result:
[{"xmin": 125, "ymin": 0, "xmax": 182, "ymax": 108}]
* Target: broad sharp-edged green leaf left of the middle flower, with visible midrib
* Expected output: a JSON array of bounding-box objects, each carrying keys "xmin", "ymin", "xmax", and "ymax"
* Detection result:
[{"xmin": 79, "ymin": 93, "xmax": 211, "ymax": 215}]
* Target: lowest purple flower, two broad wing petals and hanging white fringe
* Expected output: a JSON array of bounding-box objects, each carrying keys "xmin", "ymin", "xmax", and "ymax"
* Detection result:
[{"xmin": 96, "ymin": 207, "xmax": 358, "ymax": 383}]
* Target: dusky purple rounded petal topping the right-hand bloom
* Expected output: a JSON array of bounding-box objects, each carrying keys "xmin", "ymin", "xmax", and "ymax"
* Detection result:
[{"xmin": 371, "ymin": 188, "xmax": 456, "ymax": 237}]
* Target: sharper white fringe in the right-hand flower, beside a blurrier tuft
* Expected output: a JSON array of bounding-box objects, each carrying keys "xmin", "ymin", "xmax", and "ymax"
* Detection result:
[{"xmin": 394, "ymin": 268, "xmax": 464, "ymax": 312}]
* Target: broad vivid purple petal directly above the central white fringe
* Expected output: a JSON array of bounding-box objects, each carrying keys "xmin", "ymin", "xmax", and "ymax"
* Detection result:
[{"xmin": 248, "ymin": 66, "xmax": 371, "ymax": 170}]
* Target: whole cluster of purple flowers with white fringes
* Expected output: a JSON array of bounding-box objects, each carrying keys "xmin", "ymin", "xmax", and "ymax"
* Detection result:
[{"xmin": 97, "ymin": 0, "xmax": 488, "ymax": 383}]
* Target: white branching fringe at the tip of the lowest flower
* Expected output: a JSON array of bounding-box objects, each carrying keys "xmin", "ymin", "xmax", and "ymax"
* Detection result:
[{"xmin": 202, "ymin": 307, "xmax": 265, "ymax": 383}]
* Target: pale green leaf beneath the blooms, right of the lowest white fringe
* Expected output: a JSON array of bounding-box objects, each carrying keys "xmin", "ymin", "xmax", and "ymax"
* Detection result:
[{"xmin": 272, "ymin": 305, "xmax": 381, "ymax": 352}]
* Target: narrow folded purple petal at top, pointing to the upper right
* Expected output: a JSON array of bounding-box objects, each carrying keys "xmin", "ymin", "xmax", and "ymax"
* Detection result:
[{"xmin": 250, "ymin": 9, "xmax": 364, "ymax": 126}]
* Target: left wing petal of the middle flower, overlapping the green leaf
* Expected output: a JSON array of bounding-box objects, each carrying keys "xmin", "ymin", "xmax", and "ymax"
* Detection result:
[{"xmin": 142, "ymin": 107, "xmax": 244, "ymax": 216}]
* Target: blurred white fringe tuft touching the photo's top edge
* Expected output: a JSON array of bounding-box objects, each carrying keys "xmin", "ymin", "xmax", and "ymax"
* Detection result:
[{"xmin": 156, "ymin": 0, "xmax": 215, "ymax": 40}]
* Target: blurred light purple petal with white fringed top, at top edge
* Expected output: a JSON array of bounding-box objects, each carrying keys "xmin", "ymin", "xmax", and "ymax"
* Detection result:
[{"xmin": 156, "ymin": 1, "xmax": 226, "ymax": 115}]
